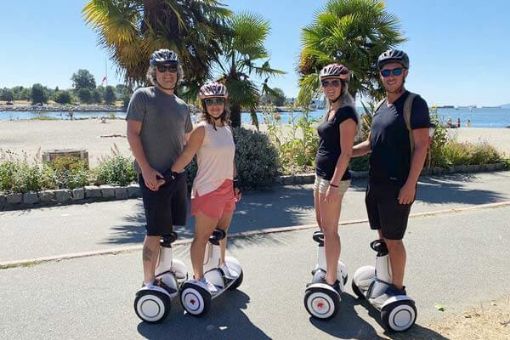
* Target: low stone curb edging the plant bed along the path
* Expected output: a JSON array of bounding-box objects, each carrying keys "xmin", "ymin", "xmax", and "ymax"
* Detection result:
[{"xmin": 0, "ymin": 163, "xmax": 507, "ymax": 211}]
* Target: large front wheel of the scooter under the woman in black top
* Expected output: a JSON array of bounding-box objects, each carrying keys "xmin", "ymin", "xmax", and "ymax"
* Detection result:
[{"xmin": 304, "ymin": 288, "xmax": 340, "ymax": 320}]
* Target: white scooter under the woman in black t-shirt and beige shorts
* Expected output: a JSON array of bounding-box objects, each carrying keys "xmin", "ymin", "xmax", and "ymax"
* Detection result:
[{"xmin": 304, "ymin": 231, "xmax": 347, "ymax": 319}]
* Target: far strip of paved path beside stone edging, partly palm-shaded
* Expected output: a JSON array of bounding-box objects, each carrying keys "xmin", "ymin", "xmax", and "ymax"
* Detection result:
[{"xmin": 0, "ymin": 171, "xmax": 510, "ymax": 264}]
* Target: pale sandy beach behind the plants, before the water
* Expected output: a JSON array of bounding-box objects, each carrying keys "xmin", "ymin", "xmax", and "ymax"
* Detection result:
[{"xmin": 0, "ymin": 119, "xmax": 510, "ymax": 167}]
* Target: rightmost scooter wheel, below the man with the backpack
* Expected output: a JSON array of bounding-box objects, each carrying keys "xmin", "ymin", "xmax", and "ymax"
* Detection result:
[{"xmin": 381, "ymin": 300, "xmax": 418, "ymax": 332}]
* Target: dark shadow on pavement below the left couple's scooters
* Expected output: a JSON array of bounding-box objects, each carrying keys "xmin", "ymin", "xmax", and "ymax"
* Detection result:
[{"xmin": 138, "ymin": 290, "xmax": 270, "ymax": 339}]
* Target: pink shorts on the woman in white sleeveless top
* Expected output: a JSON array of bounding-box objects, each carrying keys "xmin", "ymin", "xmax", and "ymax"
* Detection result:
[{"xmin": 191, "ymin": 179, "xmax": 236, "ymax": 219}]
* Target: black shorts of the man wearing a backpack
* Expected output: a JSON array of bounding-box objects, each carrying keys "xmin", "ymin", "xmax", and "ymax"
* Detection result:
[{"xmin": 365, "ymin": 183, "xmax": 412, "ymax": 240}]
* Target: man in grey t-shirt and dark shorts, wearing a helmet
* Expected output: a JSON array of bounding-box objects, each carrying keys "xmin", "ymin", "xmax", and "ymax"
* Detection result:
[{"xmin": 126, "ymin": 49, "xmax": 193, "ymax": 286}]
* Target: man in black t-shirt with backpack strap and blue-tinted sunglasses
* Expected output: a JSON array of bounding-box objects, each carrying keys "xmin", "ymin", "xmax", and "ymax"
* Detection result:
[{"xmin": 353, "ymin": 50, "xmax": 431, "ymax": 295}]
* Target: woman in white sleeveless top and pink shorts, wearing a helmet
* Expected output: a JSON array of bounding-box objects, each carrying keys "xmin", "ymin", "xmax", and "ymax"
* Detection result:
[{"xmin": 171, "ymin": 82, "xmax": 241, "ymax": 294}]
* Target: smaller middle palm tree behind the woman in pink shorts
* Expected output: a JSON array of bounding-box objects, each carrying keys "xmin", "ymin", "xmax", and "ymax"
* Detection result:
[{"xmin": 216, "ymin": 13, "xmax": 285, "ymax": 127}]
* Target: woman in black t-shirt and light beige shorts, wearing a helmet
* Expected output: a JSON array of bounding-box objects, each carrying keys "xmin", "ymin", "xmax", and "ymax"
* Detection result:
[{"xmin": 314, "ymin": 64, "xmax": 358, "ymax": 293}]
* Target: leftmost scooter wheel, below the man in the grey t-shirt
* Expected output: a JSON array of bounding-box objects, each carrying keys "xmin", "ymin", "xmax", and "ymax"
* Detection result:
[{"xmin": 134, "ymin": 290, "xmax": 171, "ymax": 323}]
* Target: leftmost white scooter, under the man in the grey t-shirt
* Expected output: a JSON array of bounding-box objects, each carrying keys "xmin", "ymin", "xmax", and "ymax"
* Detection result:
[{"xmin": 134, "ymin": 232, "xmax": 188, "ymax": 323}]
